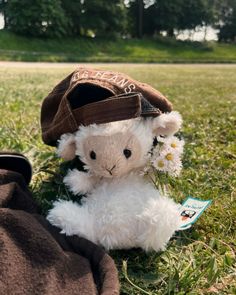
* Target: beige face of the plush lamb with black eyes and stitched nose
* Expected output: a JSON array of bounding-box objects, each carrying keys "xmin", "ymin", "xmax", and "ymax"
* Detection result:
[{"xmin": 81, "ymin": 129, "xmax": 143, "ymax": 178}]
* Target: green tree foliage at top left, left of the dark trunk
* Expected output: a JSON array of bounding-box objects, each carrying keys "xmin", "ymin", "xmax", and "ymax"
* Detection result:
[{"xmin": 0, "ymin": 0, "xmax": 126, "ymax": 37}]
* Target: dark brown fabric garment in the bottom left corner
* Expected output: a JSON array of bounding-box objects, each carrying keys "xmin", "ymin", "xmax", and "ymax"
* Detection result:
[{"xmin": 0, "ymin": 170, "xmax": 119, "ymax": 295}]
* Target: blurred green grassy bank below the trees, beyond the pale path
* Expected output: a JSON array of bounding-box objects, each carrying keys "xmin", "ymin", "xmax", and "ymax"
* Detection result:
[{"xmin": 0, "ymin": 30, "xmax": 236, "ymax": 63}]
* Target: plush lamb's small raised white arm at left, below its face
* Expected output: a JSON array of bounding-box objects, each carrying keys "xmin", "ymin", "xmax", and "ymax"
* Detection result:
[{"xmin": 63, "ymin": 169, "xmax": 93, "ymax": 195}]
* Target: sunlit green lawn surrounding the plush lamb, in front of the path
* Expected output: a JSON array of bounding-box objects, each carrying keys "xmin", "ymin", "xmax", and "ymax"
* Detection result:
[{"xmin": 0, "ymin": 64, "xmax": 236, "ymax": 295}]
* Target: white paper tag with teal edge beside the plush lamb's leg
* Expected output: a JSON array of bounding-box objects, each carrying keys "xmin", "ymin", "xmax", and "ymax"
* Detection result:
[{"xmin": 179, "ymin": 197, "xmax": 212, "ymax": 230}]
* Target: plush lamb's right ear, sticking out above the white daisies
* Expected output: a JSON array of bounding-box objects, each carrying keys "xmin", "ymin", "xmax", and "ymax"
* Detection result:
[{"xmin": 152, "ymin": 112, "xmax": 182, "ymax": 135}]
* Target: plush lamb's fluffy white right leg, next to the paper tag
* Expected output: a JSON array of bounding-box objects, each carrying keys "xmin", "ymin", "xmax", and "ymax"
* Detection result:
[{"xmin": 138, "ymin": 197, "xmax": 180, "ymax": 251}]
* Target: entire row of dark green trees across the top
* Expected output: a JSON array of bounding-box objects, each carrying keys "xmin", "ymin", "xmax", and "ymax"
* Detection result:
[{"xmin": 0, "ymin": 0, "xmax": 236, "ymax": 42}]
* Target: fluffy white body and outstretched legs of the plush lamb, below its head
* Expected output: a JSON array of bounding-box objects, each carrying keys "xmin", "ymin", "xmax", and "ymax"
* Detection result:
[{"xmin": 47, "ymin": 175, "xmax": 180, "ymax": 251}]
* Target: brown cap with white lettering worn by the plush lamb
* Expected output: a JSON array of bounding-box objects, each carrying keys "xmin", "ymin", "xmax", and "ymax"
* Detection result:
[{"xmin": 41, "ymin": 67, "xmax": 172, "ymax": 146}]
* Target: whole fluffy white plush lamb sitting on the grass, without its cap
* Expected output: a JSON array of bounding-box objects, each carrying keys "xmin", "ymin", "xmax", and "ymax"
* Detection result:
[{"xmin": 47, "ymin": 112, "xmax": 182, "ymax": 251}]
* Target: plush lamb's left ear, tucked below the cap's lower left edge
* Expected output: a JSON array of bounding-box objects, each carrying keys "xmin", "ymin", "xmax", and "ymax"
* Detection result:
[{"xmin": 57, "ymin": 133, "xmax": 76, "ymax": 161}]
